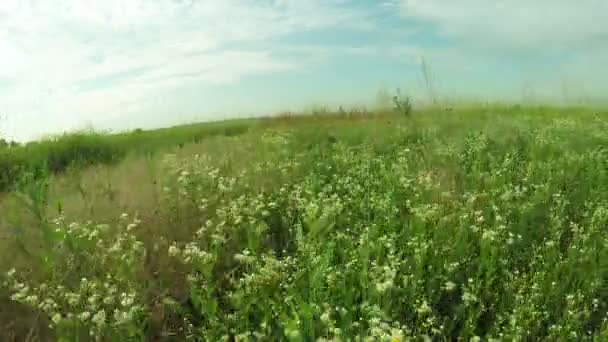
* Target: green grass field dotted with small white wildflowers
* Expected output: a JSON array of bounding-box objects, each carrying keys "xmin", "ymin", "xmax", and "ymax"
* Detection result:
[{"xmin": 0, "ymin": 105, "xmax": 608, "ymax": 341}]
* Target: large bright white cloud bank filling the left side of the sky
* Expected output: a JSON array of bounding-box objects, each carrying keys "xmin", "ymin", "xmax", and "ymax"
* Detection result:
[{"xmin": 0, "ymin": 0, "xmax": 369, "ymax": 138}]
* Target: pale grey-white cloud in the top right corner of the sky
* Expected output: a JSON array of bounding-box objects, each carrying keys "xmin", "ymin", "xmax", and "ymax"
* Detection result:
[{"xmin": 400, "ymin": 0, "xmax": 608, "ymax": 52}]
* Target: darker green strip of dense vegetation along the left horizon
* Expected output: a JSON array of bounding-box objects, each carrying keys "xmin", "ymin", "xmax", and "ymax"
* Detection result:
[{"xmin": 0, "ymin": 120, "xmax": 249, "ymax": 192}]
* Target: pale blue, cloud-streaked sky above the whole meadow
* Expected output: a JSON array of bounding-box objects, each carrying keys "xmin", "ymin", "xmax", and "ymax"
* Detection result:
[{"xmin": 0, "ymin": 0, "xmax": 608, "ymax": 141}]
